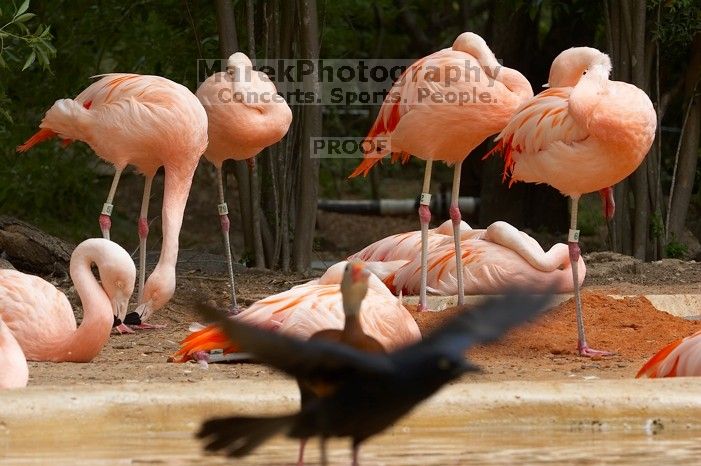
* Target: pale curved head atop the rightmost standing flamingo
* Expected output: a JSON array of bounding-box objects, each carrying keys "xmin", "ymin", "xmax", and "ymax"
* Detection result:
[{"xmin": 545, "ymin": 47, "xmax": 611, "ymax": 87}]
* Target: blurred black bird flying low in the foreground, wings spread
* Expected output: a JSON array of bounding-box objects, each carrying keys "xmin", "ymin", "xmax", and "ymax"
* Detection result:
[{"xmin": 197, "ymin": 291, "xmax": 550, "ymax": 464}]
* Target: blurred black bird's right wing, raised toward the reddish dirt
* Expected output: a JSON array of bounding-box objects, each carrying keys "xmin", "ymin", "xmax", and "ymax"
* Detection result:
[{"xmin": 390, "ymin": 290, "xmax": 552, "ymax": 368}]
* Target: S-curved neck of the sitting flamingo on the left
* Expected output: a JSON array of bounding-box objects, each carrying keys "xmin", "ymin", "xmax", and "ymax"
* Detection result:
[{"xmin": 56, "ymin": 251, "xmax": 114, "ymax": 362}]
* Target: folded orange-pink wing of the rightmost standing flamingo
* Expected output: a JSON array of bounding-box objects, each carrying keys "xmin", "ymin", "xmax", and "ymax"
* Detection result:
[{"xmin": 495, "ymin": 87, "xmax": 589, "ymax": 181}]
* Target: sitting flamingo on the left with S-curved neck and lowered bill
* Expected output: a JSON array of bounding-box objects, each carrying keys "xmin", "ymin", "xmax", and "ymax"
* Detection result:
[{"xmin": 0, "ymin": 238, "xmax": 136, "ymax": 362}]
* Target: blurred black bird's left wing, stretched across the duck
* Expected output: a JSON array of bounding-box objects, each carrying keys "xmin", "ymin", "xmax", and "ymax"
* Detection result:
[{"xmin": 197, "ymin": 303, "xmax": 394, "ymax": 383}]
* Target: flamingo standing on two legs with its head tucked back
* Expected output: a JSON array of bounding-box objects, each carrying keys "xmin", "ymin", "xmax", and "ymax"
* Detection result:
[{"xmin": 350, "ymin": 32, "xmax": 533, "ymax": 310}]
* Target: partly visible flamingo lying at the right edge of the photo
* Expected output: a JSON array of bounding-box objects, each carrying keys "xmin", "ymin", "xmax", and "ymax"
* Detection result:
[{"xmin": 635, "ymin": 331, "xmax": 701, "ymax": 379}]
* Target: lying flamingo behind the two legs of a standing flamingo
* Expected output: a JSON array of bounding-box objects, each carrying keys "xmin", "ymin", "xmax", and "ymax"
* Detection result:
[{"xmin": 349, "ymin": 221, "xmax": 586, "ymax": 295}]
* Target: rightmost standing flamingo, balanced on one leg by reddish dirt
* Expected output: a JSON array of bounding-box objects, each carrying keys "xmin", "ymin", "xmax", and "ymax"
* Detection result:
[{"xmin": 486, "ymin": 47, "xmax": 657, "ymax": 356}]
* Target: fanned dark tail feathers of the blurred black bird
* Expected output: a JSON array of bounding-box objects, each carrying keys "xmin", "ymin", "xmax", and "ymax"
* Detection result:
[{"xmin": 197, "ymin": 414, "xmax": 297, "ymax": 457}]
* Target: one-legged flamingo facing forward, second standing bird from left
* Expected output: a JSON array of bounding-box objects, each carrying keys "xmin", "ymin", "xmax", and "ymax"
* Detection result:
[{"xmin": 196, "ymin": 52, "xmax": 292, "ymax": 310}]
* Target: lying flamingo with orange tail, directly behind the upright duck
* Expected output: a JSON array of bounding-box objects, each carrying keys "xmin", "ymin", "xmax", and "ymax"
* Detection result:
[{"xmin": 174, "ymin": 261, "xmax": 421, "ymax": 362}]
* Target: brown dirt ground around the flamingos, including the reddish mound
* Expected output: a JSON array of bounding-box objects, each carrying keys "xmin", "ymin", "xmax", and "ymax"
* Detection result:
[{"xmin": 23, "ymin": 231, "xmax": 701, "ymax": 386}]
